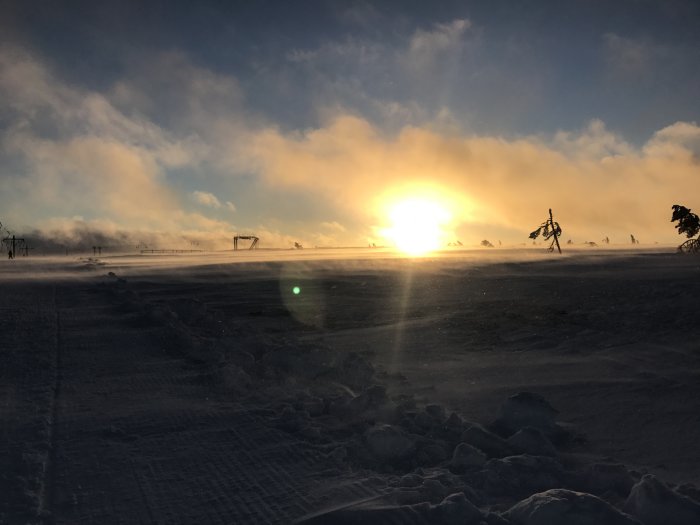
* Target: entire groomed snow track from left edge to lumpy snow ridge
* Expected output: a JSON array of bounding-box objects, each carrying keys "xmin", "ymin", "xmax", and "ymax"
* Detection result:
[{"xmin": 0, "ymin": 276, "xmax": 376, "ymax": 524}]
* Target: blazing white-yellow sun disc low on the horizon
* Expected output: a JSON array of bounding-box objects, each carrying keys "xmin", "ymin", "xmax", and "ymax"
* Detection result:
[{"xmin": 382, "ymin": 198, "xmax": 451, "ymax": 256}]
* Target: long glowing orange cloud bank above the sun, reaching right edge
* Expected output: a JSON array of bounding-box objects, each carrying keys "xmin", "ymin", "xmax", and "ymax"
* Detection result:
[{"xmin": 252, "ymin": 115, "xmax": 700, "ymax": 241}]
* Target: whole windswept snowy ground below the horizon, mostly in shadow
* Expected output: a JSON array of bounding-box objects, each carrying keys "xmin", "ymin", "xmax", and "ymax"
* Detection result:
[{"xmin": 0, "ymin": 249, "xmax": 700, "ymax": 525}]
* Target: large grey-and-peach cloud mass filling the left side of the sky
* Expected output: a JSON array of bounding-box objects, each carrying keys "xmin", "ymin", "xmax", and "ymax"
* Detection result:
[{"xmin": 0, "ymin": 46, "xmax": 246, "ymax": 237}]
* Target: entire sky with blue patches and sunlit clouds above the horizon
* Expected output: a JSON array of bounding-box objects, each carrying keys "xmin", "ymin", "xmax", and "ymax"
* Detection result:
[{"xmin": 0, "ymin": 0, "xmax": 700, "ymax": 249}]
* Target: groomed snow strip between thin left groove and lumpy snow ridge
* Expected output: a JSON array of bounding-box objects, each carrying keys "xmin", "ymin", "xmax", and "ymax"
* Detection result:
[{"xmin": 45, "ymin": 288, "xmax": 372, "ymax": 524}]
